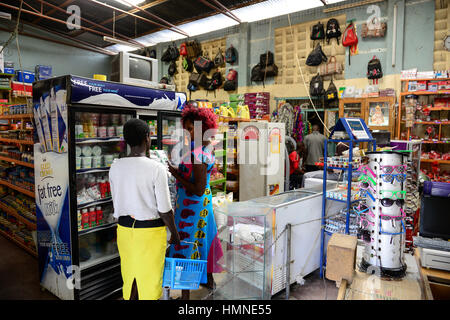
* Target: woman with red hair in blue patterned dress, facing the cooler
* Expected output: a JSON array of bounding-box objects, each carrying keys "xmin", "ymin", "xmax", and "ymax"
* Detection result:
[{"xmin": 169, "ymin": 104, "xmax": 223, "ymax": 300}]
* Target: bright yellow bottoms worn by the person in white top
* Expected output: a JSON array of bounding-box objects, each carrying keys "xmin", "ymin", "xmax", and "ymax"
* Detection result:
[{"xmin": 117, "ymin": 225, "xmax": 167, "ymax": 300}]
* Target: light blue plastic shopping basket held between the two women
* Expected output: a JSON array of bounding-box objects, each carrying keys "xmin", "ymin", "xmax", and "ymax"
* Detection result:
[{"xmin": 163, "ymin": 258, "xmax": 207, "ymax": 290}]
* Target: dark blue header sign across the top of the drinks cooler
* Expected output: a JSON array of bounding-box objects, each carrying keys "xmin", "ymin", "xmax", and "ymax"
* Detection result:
[{"xmin": 70, "ymin": 76, "xmax": 186, "ymax": 110}]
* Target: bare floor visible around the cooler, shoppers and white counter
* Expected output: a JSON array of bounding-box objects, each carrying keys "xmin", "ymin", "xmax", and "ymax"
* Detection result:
[{"xmin": 0, "ymin": 235, "xmax": 338, "ymax": 300}]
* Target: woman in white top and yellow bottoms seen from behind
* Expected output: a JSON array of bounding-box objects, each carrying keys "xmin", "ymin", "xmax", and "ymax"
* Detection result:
[{"xmin": 109, "ymin": 119, "xmax": 180, "ymax": 300}]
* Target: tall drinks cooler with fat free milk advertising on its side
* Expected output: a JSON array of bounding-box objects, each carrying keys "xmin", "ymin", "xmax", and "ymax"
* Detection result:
[{"xmin": 33, "ymin": 76, "xmax": 186, "ymax": 300}]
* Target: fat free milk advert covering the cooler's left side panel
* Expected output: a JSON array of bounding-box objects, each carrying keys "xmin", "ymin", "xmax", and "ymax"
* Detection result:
[{"xmin": 33, "ymin": 78, "xmax": 74, "ymax": 300}]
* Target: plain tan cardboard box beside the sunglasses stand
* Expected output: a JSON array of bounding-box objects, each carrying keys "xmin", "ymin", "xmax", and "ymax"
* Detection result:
[{"xmin": 325, "ymin": 233, "xmax": 358, "ymax": 283}]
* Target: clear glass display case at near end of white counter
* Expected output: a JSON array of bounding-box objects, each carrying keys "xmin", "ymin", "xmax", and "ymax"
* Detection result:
[{"xmin": 214, "ymin": 203, "xmax": 272, "ymax": 300}]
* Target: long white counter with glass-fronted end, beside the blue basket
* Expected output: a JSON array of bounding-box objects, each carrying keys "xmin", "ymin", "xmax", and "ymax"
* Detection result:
[{"xmin": 214, "ymin": 182, "xmax": 345, "ymax": 300}]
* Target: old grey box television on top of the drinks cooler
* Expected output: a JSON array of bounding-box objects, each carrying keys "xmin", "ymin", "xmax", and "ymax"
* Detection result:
[{"xmin": 111, "ymin": 52, "xmax": 175, "ymax": 90}]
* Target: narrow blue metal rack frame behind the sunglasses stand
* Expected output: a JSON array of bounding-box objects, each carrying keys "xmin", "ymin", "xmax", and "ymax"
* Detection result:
[{"xmin": 320, "ymin": 118, "xmax": 376, "ymax": 278}]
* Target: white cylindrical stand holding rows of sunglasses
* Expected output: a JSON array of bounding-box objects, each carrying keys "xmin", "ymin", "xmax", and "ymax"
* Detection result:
[{"xmin": 357, "ymin": 151, "xmax": 408, "ymax": 278}]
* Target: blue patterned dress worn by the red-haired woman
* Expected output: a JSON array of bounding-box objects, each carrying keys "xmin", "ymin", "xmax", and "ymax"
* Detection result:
[{"xmin": 169, "ymin": 146, "xmax": 223, "ymax": 283}]
